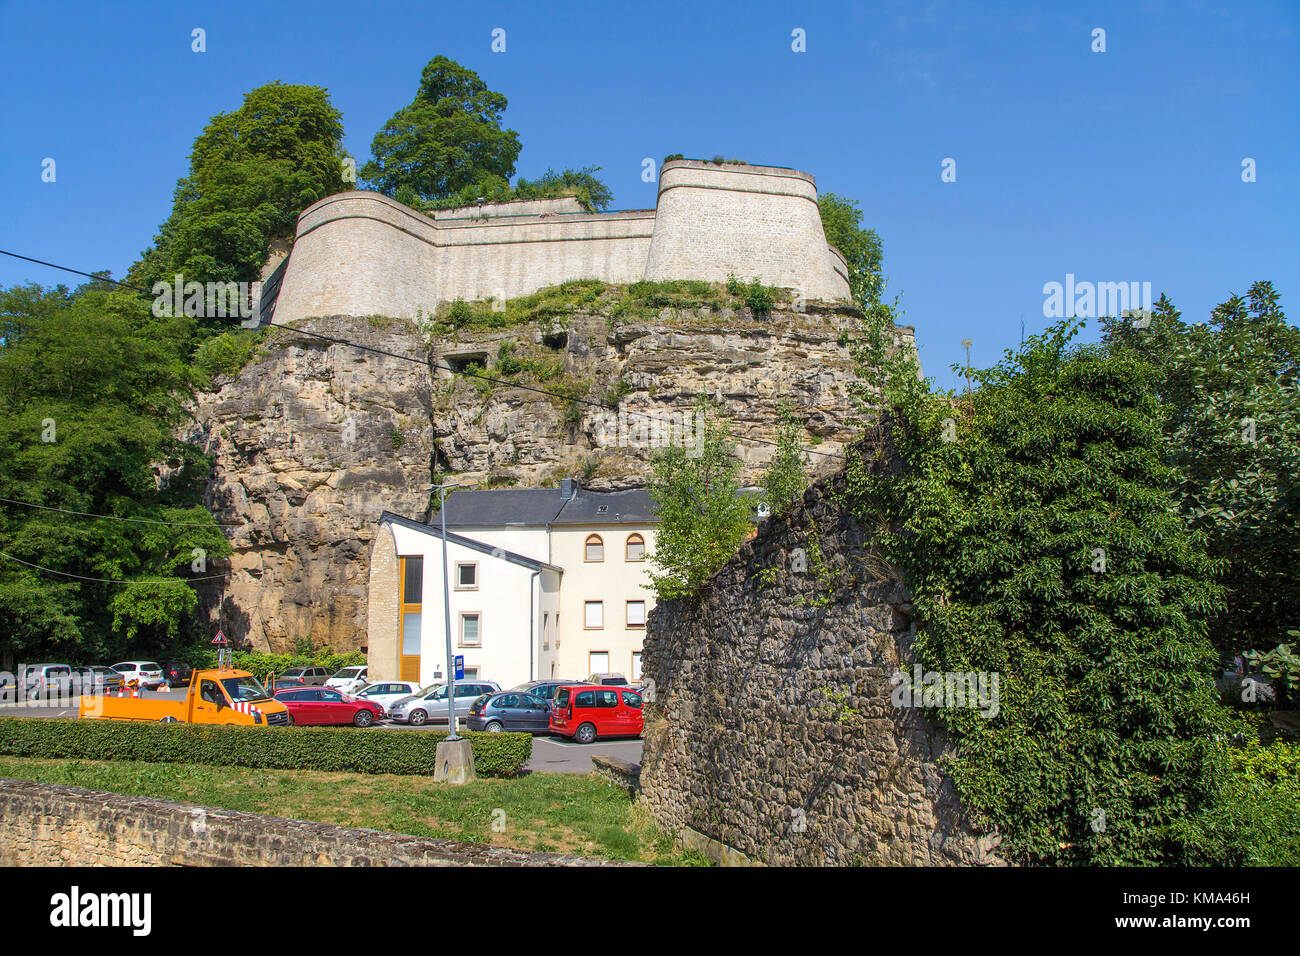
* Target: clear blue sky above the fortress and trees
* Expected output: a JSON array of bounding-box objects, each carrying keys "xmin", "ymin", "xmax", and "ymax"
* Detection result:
[{"xmin": 0, "ymin": 0, "xmax": 1300, "ymax": 385}]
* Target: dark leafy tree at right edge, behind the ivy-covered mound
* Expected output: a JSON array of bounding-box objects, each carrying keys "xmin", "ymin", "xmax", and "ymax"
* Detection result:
[{"xmin": 1104, "ymin": 282, "xmax": 1300, "ymax": 656}]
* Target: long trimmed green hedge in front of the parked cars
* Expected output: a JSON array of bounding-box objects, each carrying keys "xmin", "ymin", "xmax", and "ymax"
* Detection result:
[{"xmin": 0, "ymin": 717, "xmax": 533, "ymax": 777}]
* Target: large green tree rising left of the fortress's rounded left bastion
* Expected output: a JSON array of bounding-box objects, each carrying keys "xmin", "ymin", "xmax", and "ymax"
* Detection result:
[{"xmin": 127, "ymin": 82, "xmax": 351, "ymax": 299}]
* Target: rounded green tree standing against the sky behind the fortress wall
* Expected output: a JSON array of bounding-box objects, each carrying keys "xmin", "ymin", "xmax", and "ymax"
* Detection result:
[{"xmin": 361, "ymin": 56, "xmax": 521, "ymax": 202}]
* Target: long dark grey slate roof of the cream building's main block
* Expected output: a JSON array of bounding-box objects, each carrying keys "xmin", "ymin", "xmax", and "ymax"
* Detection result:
[{"xmin": 432, "ymin": 488, "xmax": 655, "ymax": 538}]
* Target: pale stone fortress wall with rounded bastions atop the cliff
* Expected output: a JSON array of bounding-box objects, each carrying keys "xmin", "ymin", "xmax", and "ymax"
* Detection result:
[{"xmin": 276, "ymin": 160, "xmax": 849, "ymax": 324}]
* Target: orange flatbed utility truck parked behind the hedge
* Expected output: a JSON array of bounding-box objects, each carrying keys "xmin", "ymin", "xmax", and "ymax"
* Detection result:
[{"xmin": 77, "ymin": 667, "xmax": 290, "ymax": 726}]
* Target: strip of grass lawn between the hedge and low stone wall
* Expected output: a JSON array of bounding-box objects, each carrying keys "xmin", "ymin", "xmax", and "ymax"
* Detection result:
[{"xmin": 0, "ymin": 757, "xmax": 706, "ymax": 865}]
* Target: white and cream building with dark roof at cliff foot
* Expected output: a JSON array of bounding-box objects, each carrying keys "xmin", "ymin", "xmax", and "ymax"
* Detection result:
[{"xmin": 367, "ymin": 479, "xmax": 657, "ymax": 687}]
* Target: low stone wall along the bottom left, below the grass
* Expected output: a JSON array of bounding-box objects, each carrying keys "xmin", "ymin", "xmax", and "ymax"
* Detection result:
[{"xmin": 0, "ymin": 779, "xmax": 616, "ymax": 866}]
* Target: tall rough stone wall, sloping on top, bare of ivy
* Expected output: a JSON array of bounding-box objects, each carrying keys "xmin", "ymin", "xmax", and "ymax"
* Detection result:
[{"xmin": 641, "ymin": 431, "xmax": 1000, "ymax": 865}]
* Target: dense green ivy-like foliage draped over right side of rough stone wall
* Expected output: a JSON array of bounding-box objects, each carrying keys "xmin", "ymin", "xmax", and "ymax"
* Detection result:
[{"xmin": 850, "ymin": 324, "xmax": 1223, "ymax": 865}]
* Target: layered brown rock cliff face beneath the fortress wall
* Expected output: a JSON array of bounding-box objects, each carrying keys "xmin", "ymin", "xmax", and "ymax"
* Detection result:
[{"xmin": 191, "ymin": 306, "xmax": 878, "ymax": 650}]
